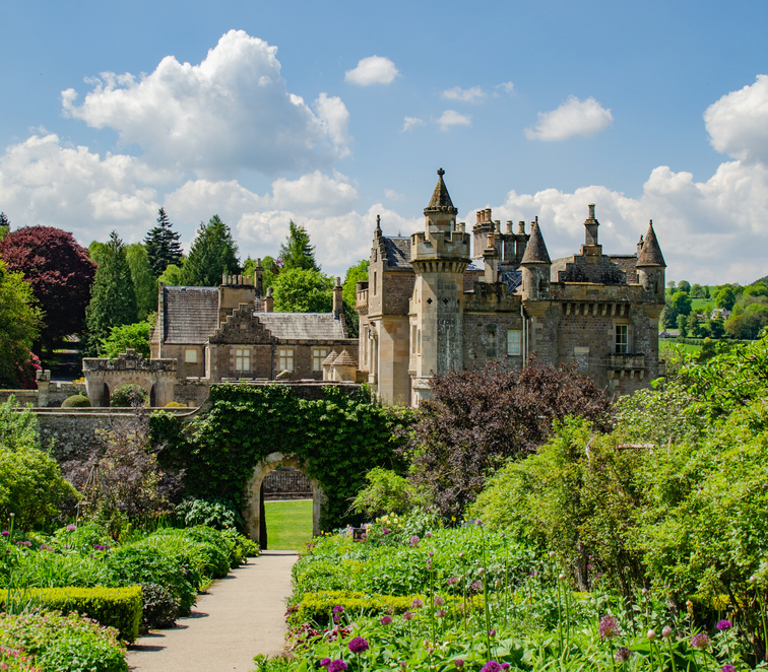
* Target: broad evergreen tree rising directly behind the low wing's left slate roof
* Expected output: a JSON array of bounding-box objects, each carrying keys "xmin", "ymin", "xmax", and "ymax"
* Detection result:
[{"xmin": 182, "ymin": 215, "xmax": 240, "ymax": 287}]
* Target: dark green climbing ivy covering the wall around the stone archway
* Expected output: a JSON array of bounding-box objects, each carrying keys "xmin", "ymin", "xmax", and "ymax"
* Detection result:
[{"xmin": 151, "ymin": 385, "xmax": 412, "ymax": 530}]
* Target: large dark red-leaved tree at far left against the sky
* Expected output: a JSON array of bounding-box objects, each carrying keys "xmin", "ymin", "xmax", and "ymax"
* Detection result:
[{"xmin": 0, "ymin": 226, "xmax": 96, "ymax": 349}]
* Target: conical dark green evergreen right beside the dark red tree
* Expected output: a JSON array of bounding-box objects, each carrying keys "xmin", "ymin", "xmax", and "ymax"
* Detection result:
[{"xmin": 85, "ymin": 231, "xmax": 138, "ymax": 356}]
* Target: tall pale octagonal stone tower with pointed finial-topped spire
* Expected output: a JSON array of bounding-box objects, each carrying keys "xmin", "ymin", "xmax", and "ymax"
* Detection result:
[{"xmin": 409, "ymin": 168, "xmax": 470, "ymax": 405}]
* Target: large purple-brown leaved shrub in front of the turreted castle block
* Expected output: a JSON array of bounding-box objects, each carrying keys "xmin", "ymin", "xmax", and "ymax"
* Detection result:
[{"xmin": 405, "ymin": 359, "xmax": 611, "ymax": 520}]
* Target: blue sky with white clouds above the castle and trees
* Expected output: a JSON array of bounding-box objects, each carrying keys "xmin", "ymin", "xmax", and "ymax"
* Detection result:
[{"xmin": 0, "ymin": 0, "xmax": 768, "ymax": 284}]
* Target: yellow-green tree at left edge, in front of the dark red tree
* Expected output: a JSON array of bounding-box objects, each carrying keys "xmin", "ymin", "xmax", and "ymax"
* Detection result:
[{"xmin": 0, "ymin": 259, "xmax": 40, "ymax": 388}]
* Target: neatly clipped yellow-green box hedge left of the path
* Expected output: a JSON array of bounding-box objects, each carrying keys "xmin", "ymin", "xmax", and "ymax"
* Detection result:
[{"xmin": 0, "ymin": 586, "xmax": 142, "ymax": 642}]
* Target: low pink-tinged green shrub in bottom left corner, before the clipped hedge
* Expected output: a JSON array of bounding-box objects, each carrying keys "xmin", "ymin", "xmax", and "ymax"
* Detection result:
[{"xmin": 0, "ymin": 612, "xmax": 128, "ymax": 672}]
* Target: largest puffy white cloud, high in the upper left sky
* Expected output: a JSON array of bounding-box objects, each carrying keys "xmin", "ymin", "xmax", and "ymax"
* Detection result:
[{"xmin": 62, "ymin": 30, "xmax": 349, "ymax": 178}]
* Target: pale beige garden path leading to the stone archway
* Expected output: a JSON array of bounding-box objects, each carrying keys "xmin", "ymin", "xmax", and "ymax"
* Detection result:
[{"xmin": 128, "ymin": 551, "xmax": 297, "ymax": 672}]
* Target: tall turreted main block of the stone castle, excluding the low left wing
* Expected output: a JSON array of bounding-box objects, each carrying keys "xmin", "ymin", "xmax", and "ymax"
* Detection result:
[{"xmin": 356, "ymin": 169, "xmax": 666, "ymax": 405}]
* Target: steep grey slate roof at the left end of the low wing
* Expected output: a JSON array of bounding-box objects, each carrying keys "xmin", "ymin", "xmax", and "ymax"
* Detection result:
[{"xmin": 163, "ymin": 287, "xmax": 219, "ymax": 345}]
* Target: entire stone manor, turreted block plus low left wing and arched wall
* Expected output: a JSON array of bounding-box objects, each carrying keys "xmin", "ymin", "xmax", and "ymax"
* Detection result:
[{"xmin": 75, "ymin": 169, "xmax": 666, "ymax": 406}]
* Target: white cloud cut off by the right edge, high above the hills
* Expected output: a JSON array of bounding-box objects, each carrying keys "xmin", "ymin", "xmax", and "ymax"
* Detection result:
[{"xmin": 704, "ymin": 75, "xmax": 768, "ymax": 163}]
